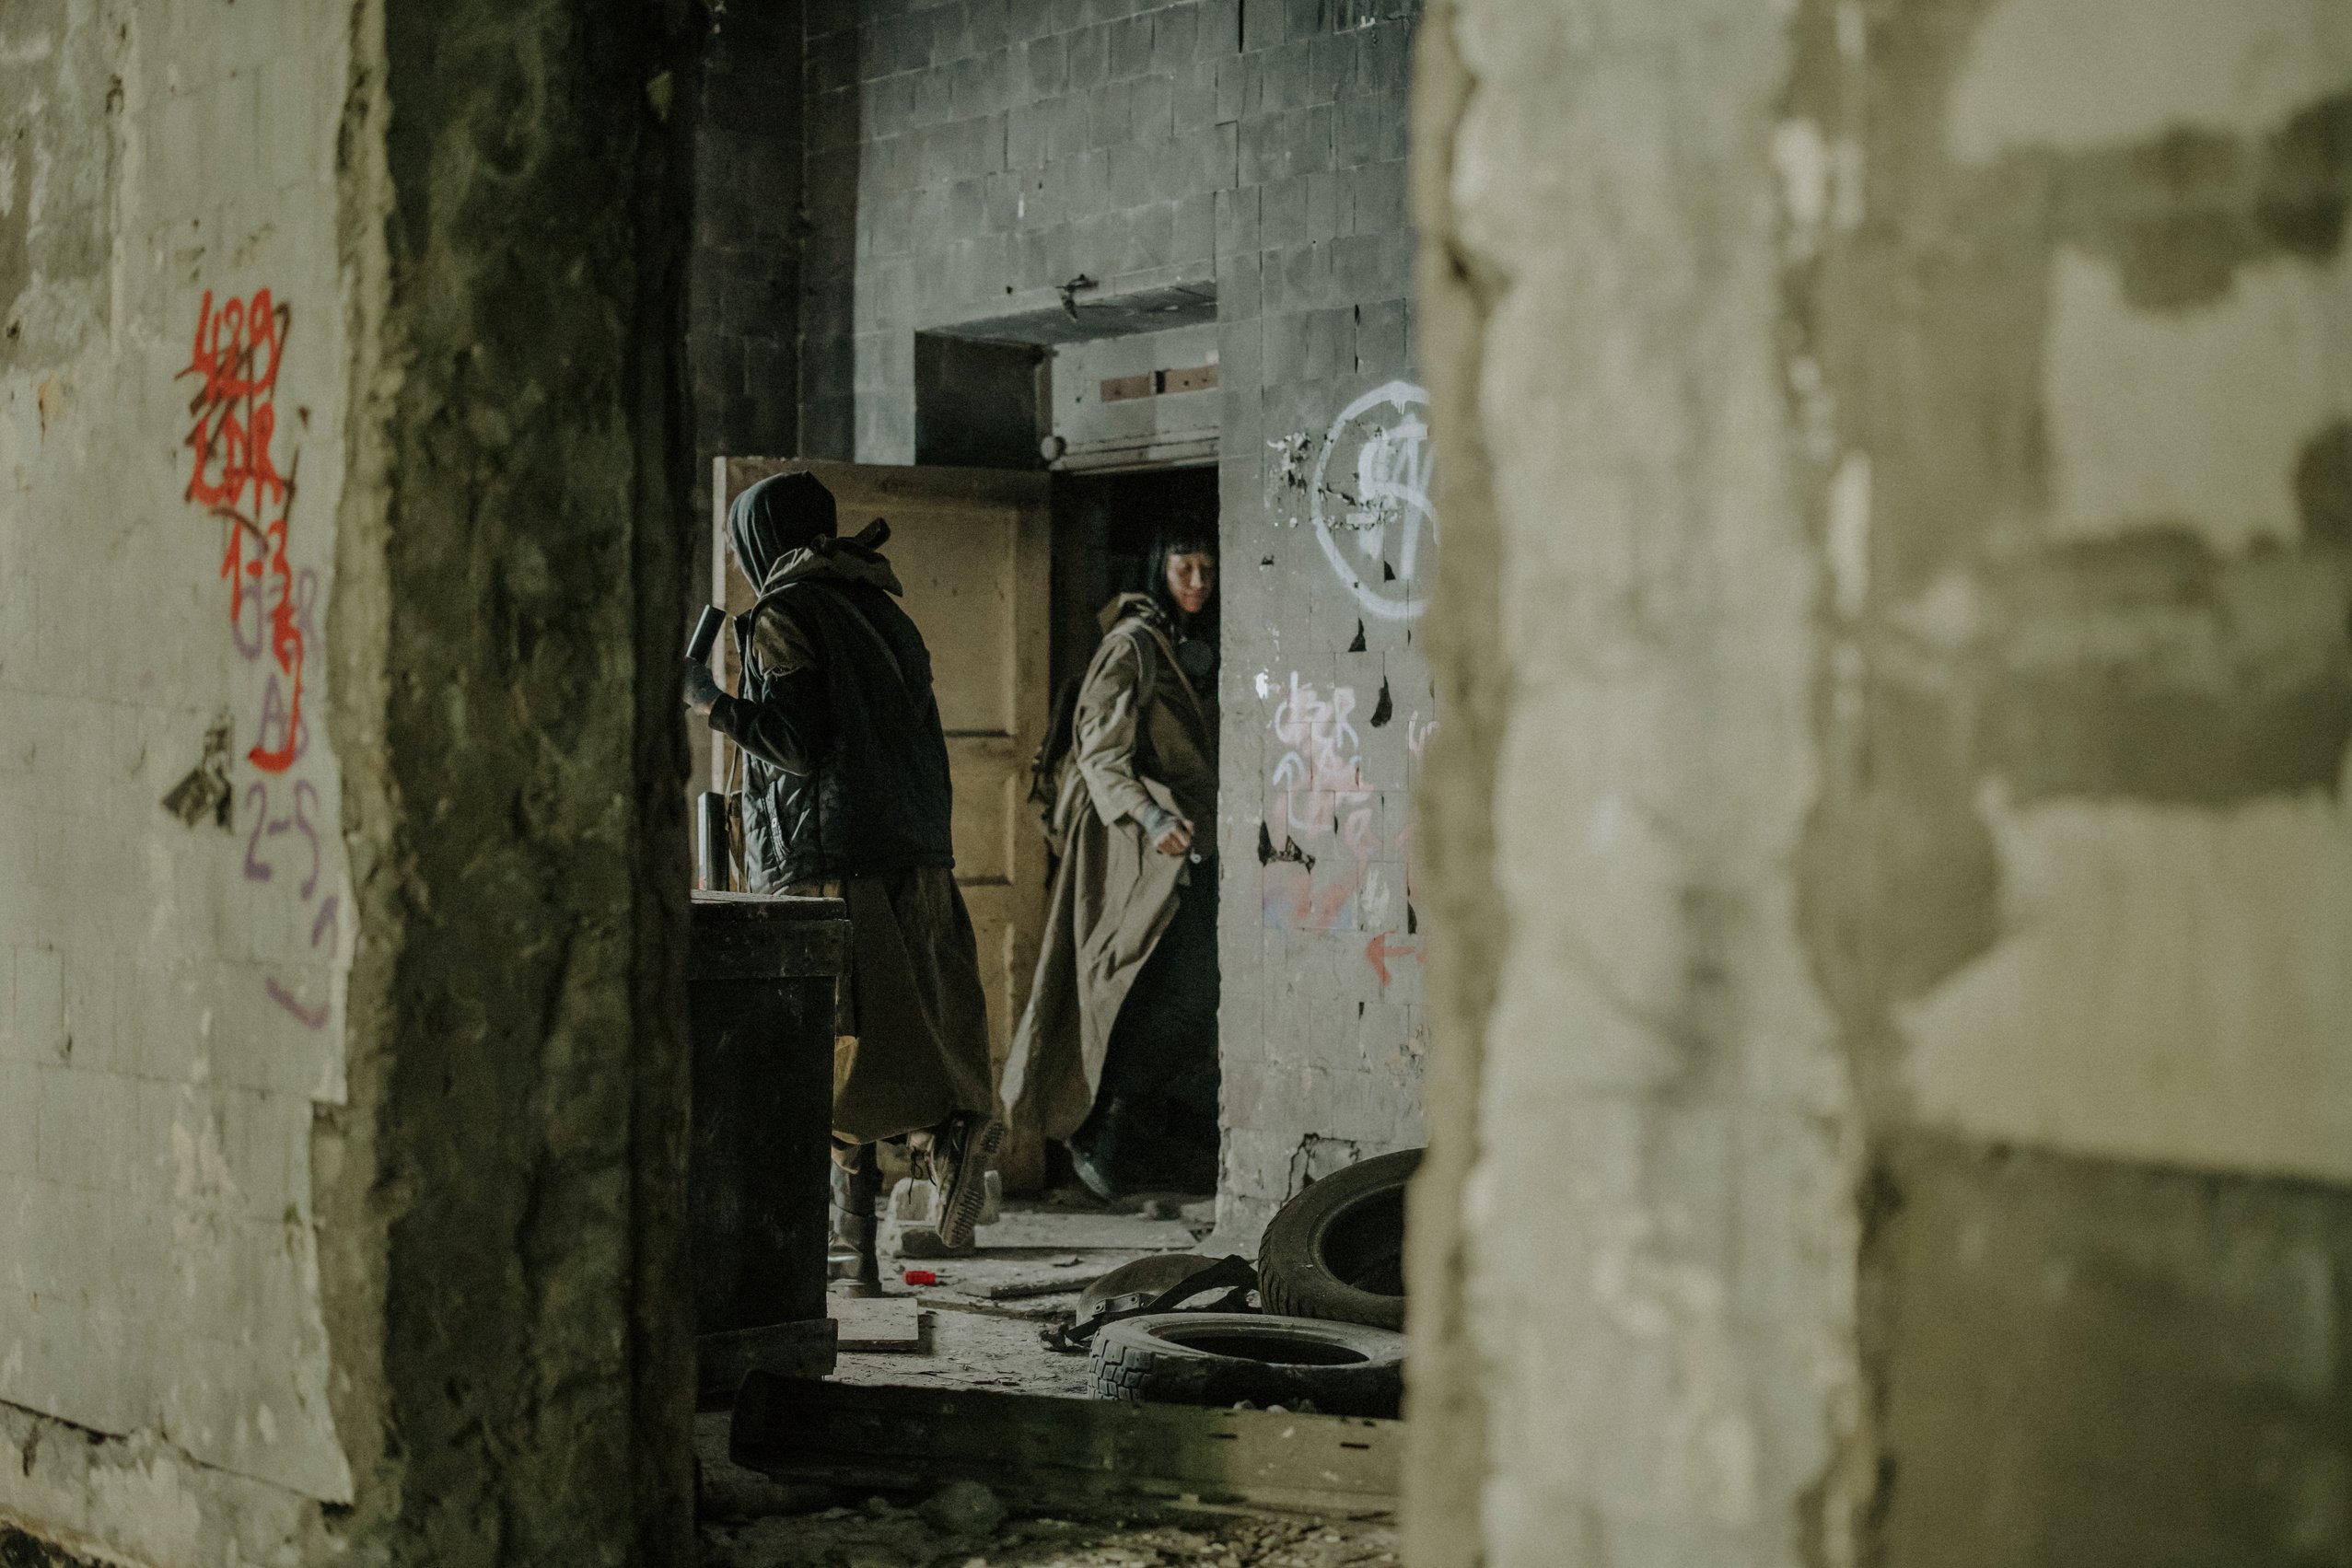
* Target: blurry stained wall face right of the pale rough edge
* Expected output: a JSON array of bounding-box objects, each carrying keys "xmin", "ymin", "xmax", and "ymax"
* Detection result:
[{"xmin": 1776, "ymin": 0, "xmax": 2352, "ymax": 1563}]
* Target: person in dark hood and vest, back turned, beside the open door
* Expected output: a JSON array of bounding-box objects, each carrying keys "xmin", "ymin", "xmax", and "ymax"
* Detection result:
[{"xmin": 687, "ymin": 472, "xmax": 1005, "ymax": 1282}]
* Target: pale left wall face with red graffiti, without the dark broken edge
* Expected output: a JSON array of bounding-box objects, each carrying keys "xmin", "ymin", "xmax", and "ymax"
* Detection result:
[{"xmin": 0, "ymin": 0, "xmax": 355, "ymax": 1561}]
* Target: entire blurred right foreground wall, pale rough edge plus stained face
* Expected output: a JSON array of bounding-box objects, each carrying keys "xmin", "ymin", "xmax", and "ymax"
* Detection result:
[{"xmin": 1411, "ymin": 0, "xmax": 2352, "ymax": 1563}]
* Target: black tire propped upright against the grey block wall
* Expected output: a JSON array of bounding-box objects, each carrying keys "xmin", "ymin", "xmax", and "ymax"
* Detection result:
[{"xmin": 1258, "ymin": 1150, "xmax": 1421, "ymax": 1329}]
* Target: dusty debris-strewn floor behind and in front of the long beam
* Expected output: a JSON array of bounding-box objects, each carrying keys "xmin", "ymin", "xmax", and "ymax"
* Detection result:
[{"xmin": 696, "ymin": 1194, "xmax": 1397, "ymax": 1568}]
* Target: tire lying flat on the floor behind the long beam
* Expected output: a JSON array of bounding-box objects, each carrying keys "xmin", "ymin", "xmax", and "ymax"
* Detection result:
[{"xmin": 1087, "ymin": 1312, "xmax": 1404, "ymax": 1418}]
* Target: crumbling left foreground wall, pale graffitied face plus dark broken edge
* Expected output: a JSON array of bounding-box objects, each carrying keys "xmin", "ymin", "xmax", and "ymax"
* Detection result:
[{"xmin": 0, "ymin": 0, "xmax": 692, "ymax": 1565}]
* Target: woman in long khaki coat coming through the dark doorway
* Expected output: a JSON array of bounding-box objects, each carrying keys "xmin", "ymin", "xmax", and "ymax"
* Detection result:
[{"xmin": 1005, "ymin": 524, "xmax": 1218, "ymax": 1199}]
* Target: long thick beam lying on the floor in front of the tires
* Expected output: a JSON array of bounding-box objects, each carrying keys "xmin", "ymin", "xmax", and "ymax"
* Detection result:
[{"xmin": 731, "ymin": 1373, "xmax": 1404, "ymax": 1512}]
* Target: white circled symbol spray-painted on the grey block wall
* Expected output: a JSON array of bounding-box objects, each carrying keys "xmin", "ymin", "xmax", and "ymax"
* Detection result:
[{"xmin": 1310, "ymin": 381, "xmax": 1437, "ymax": 621}]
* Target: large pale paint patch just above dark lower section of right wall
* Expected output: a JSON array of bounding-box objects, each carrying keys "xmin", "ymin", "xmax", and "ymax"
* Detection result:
[{"xmin": 1898, "ymin": 757, "xmax": 2352, "ymax": 1180}]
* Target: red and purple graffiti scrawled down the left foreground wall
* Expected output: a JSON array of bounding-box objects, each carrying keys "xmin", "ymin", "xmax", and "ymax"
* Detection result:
[{"xmin": 179, "ymin": 289, "xmax": 339, "ymax": 1029}]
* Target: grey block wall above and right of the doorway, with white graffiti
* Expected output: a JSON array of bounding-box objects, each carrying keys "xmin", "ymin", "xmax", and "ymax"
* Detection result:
[{"xmin": 802, "ymin": 0, "xmax": 1439, "ymax": 1246}]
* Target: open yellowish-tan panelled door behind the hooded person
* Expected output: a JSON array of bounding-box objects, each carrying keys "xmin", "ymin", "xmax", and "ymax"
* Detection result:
[{"xmin": 710, "ymin": 459, "xmax": 1052, "ymax": 1191}]
